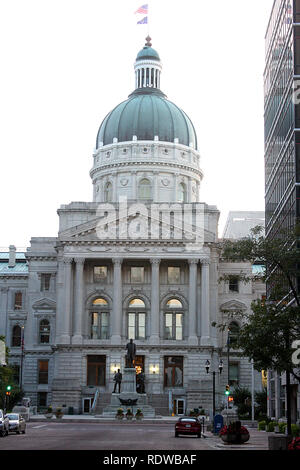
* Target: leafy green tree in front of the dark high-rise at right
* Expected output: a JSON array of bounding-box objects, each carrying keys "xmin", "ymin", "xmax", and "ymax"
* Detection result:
[{"xmin": 219, "ymin": 226, "xmax": 300, "ymax": 433}]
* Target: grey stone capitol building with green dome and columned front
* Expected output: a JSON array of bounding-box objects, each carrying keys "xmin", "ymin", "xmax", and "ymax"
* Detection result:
[{"xmin": 0, "ymin": 37, "xmax": 264, "ymax": 415}]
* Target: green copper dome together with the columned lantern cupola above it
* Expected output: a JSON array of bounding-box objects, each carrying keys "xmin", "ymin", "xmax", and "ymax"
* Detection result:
[{"xmin": 96, "ymin": 40, "xmax": 197, "ymax": 149}]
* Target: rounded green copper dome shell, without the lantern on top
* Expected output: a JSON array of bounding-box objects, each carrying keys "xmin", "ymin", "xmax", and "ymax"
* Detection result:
[{"xmin": 96, "ymin": 88, "xmax": 197, "ymax": 149}]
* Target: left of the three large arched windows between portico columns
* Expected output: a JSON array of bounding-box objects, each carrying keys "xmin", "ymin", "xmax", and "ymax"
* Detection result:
[{"xmin": 90, "ymin": 297, "xmax": 109, "ymax": 339}]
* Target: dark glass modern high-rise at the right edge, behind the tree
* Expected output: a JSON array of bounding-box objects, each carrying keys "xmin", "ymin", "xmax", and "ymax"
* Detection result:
[{"xmin": 264, "ymin": 0, "xmax": 300, "ymax": 421}]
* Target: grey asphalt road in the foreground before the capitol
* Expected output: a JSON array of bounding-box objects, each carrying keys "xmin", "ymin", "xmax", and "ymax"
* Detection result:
[{"xmin": 0, "ymin": 422, "xmax": 213, "ymax": 451}]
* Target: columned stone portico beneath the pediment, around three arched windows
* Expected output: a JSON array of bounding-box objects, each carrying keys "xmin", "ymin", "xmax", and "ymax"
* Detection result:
[{"xmin": 56, "ymin": 250, "xmax": 210, "ymax": 346}]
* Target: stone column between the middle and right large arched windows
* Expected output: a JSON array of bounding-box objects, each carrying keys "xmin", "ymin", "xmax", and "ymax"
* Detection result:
[{"xmin": 150, "ymin": 258, "xmax": 160, "ymax": 344}]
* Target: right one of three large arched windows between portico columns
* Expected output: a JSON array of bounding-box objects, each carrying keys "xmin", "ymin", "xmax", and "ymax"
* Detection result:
[{"xmin": 164, "ymin": 298, "xmax": 184, "ymax": 341}]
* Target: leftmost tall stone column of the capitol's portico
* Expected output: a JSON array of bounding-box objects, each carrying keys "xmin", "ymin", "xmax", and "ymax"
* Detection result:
[{"xmin": 60, "ymin": 258, "xmax": 73, "ymax": 344}]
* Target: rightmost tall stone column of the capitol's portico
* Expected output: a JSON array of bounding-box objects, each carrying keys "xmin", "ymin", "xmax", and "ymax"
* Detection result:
[{"xmin": 200, "ymin": 258, "xmax": 210, "ymax": 346}]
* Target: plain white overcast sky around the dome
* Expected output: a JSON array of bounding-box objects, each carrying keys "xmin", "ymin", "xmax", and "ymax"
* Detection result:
[{"xmin": 0, "ymin": 0, "xmax": 273, "ymax": 249}]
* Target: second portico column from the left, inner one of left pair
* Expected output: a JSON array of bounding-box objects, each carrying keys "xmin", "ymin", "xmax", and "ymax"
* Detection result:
[{"xmin": 72, "ymin": 258, "xmax": 85, "ymax": 344}]
